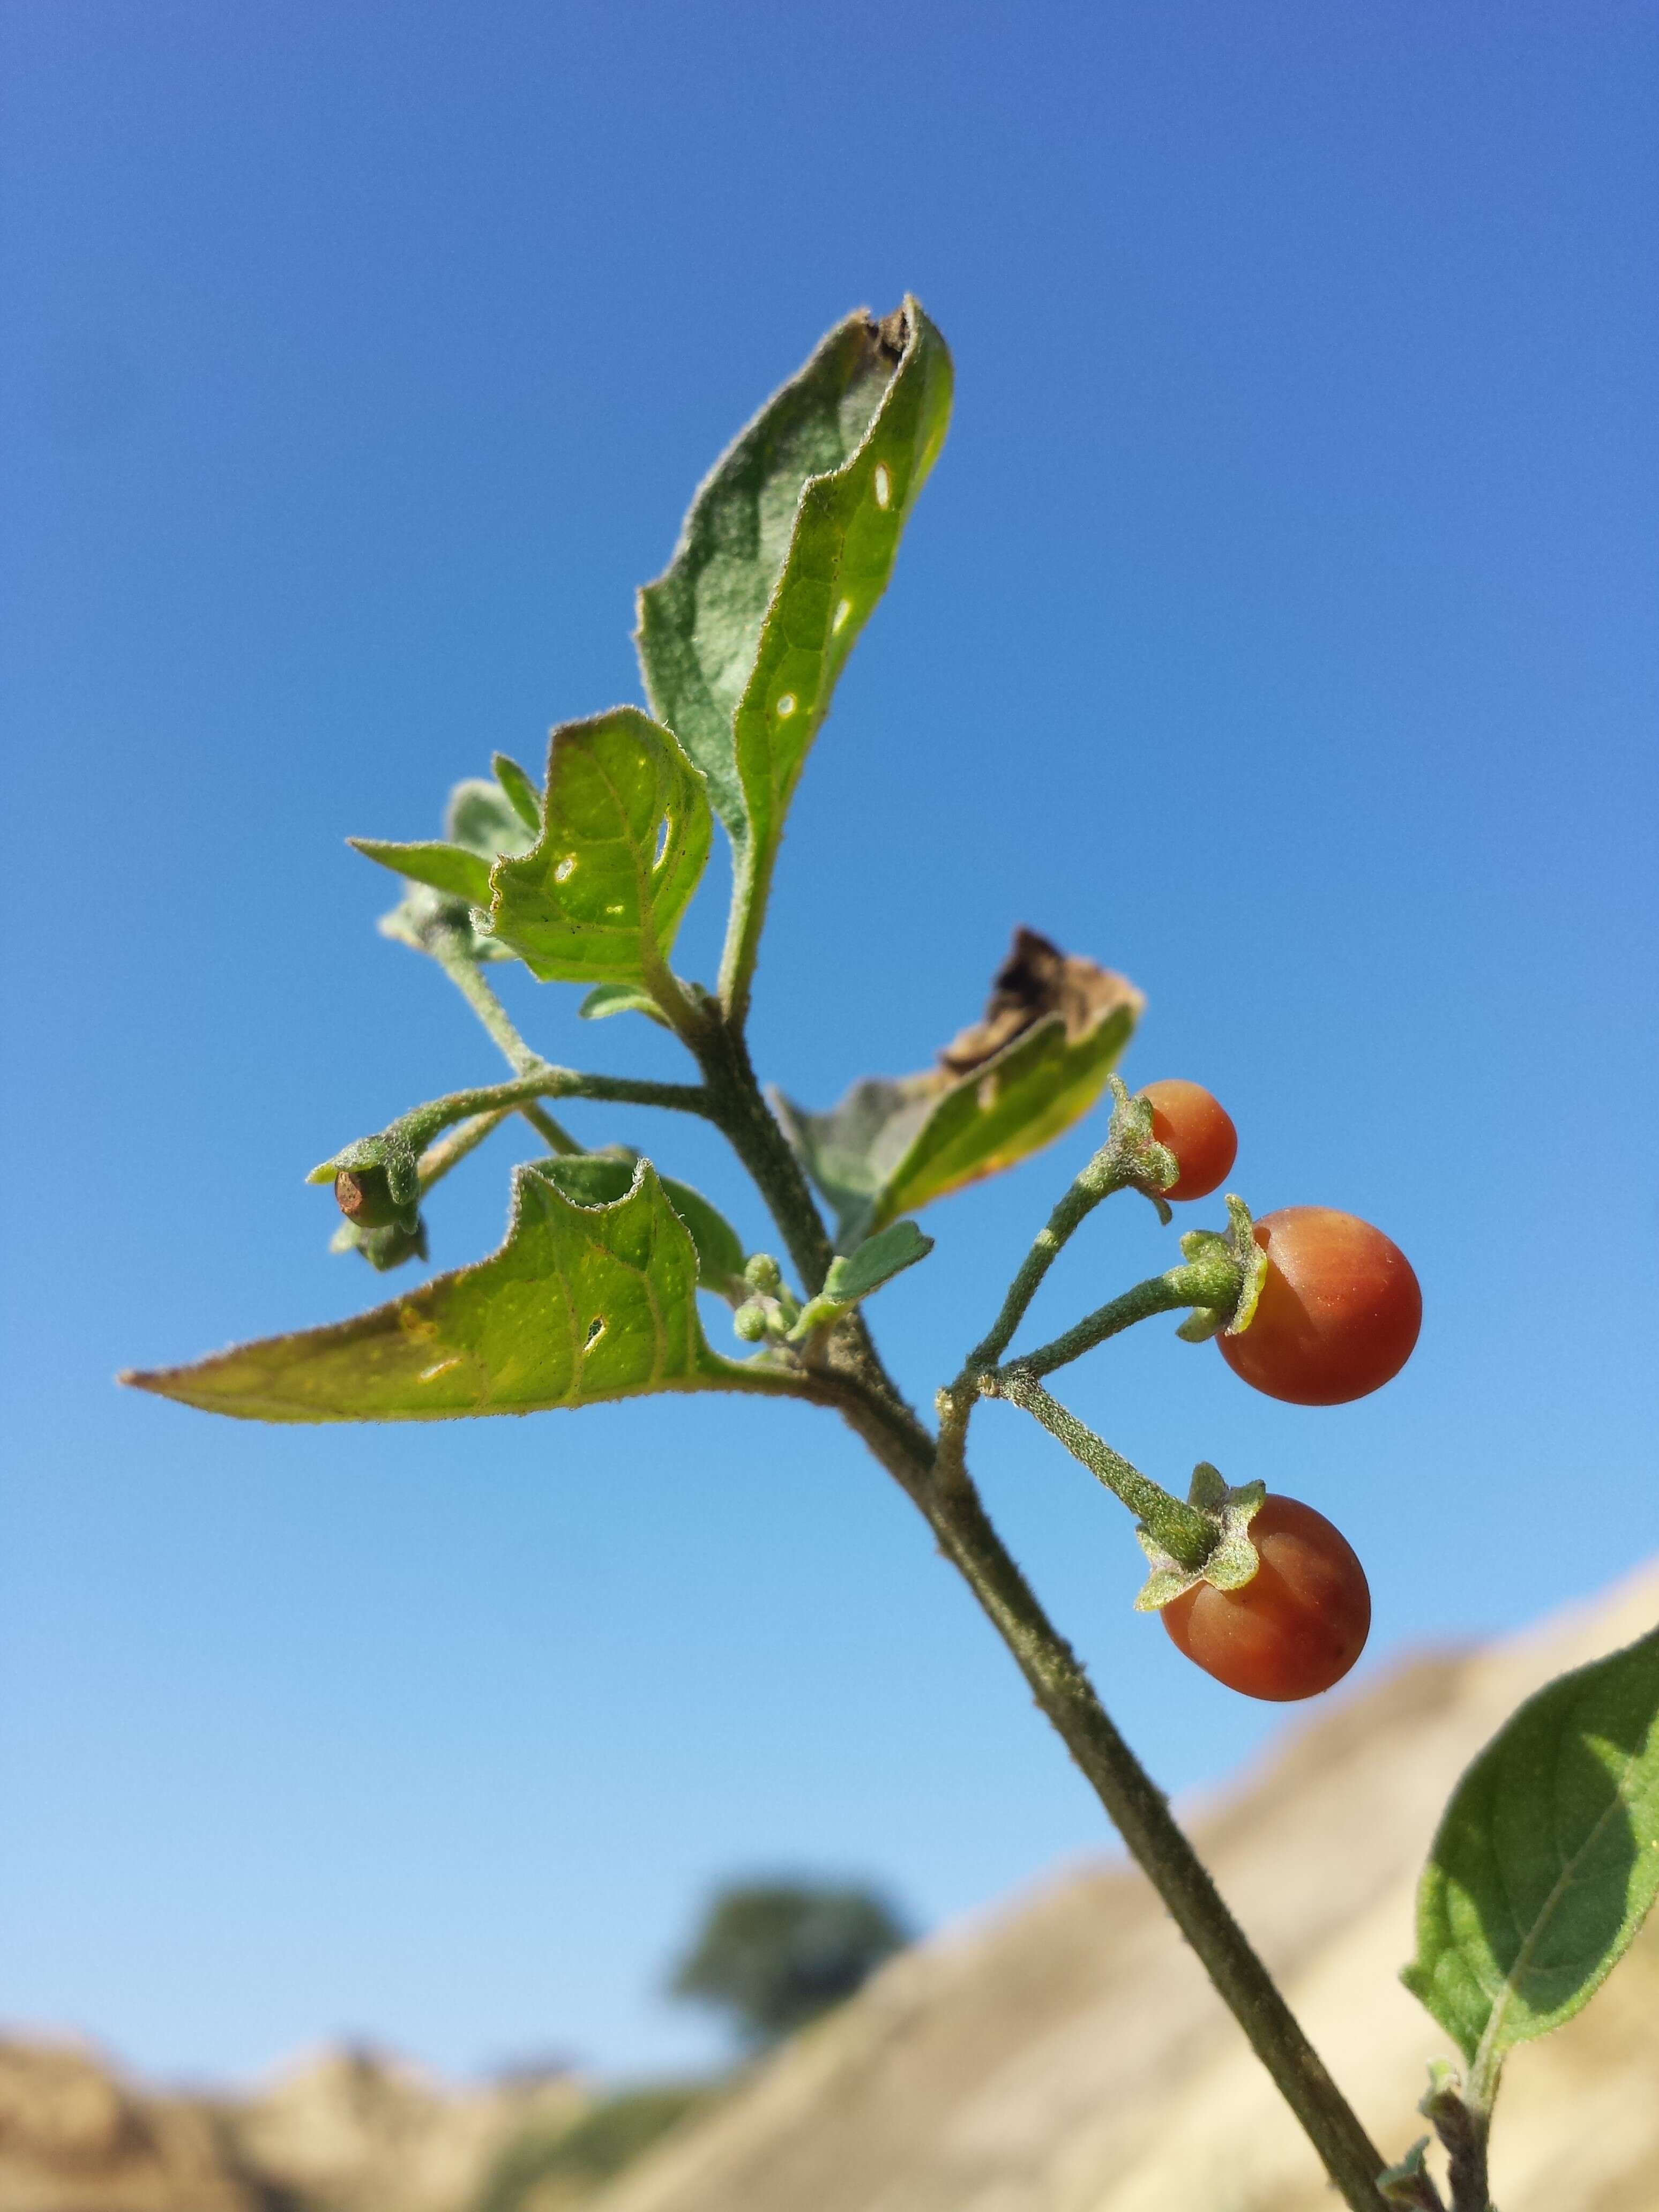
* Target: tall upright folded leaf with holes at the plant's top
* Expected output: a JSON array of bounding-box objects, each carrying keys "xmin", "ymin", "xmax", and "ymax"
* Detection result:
[{"xmin": 637, "ymin": 298, "xmax": 951, "ymax": 1000}]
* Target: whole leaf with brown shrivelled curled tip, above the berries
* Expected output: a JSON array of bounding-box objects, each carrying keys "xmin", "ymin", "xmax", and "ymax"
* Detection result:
[{"xmin": 776, "ymin": 929, "xmax": 1144, "ymax": 1245}]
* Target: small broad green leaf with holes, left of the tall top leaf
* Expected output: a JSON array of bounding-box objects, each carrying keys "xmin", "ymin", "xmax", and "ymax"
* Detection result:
[{"xmin": 491, "ymin": 706, "xmax": 712, "ymax": 984}]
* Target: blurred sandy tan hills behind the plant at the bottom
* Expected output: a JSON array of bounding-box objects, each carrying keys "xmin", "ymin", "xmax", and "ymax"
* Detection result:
[{"xmin": 13, "ymin": 1566, "xmax": 1659, "ymax": 2212}]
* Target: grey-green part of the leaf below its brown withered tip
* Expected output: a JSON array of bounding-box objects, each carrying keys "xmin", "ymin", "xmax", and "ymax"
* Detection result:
[{"xmin": 776, "ymin": 971, "xmax": 1141, "ymax": 1245}]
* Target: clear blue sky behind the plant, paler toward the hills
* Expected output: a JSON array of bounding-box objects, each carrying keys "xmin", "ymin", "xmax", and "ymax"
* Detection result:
[{"xmin": 0, "ymin": 0, "xmax": 1659, "ymax": 2077}]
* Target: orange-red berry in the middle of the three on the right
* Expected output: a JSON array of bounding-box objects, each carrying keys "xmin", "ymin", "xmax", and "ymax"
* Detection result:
[{"xmin": 1214, "ymin": 1206, "xmax": 1422, "ymax": 1404}]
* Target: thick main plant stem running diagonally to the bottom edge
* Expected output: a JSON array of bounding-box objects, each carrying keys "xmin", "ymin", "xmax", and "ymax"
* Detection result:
[{"xmin": 699, "ymin": 1024, "xmax": 1387, "ymax": 2212}]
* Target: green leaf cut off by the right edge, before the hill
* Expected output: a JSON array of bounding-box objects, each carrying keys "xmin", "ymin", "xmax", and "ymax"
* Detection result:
[{"xmin": 1402, "ymin": 1630, "xmax": 1659, "ymax": 2093}]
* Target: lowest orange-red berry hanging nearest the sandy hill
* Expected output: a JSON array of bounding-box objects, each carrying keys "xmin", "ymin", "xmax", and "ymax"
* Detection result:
[{"xmin": 1163, "ymin": 1498, "xmax": 1371, "ymax": 1706}]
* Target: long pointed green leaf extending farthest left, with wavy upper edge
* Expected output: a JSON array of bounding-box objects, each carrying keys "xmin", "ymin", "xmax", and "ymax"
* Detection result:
[{"xmin": 122, "ymin": 1159, "xmax": 779, "ymax": 1420}]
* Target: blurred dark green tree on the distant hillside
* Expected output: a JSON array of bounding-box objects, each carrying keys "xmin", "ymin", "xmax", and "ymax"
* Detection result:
[{"xmin": 670, "ymin": 1882, "xmax": 909, "ymax": 2049}]
